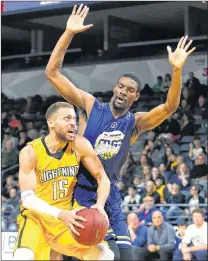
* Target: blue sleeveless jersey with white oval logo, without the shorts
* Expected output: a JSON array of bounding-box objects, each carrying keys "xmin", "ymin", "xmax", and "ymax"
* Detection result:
[{"xmin": 75, "ymin": 100, "xmax": 135, "ymax": 193}]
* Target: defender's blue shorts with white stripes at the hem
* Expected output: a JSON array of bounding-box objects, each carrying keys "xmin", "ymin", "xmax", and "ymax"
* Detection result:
[{"xmin": 74, "ymin": 184, "xmax": 132, "ymax": 248}]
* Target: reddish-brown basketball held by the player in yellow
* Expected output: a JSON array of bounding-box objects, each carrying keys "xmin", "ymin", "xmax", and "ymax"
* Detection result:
[{"xmin": 73, "ymin": 208, "xmax": 108, "ymax": 246}]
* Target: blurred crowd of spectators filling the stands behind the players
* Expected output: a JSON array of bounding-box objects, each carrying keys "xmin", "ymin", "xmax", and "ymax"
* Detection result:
[{"xmin": 1, "ymin": 72, "xmax": 208, "ymax": 260}]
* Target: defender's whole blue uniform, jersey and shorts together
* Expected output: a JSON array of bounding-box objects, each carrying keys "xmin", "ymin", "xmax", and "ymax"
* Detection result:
[{"xmin": 74, "ymin": 100, "xmax": 135, "ymax": 248}]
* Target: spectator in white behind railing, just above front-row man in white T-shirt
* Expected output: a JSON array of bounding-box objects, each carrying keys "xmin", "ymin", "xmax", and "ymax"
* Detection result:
[{"xmin": 185, "ymin": 185, "xmax": 204, "ymax": 215}]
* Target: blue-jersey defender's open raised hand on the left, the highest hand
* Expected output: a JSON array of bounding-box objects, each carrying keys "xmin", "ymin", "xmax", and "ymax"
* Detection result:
[{"xmin": 66, "ymin": 4, "xmax": 93, "ymax": 34}]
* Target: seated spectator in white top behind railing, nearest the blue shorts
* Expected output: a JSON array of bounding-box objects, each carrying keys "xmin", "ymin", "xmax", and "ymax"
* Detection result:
[{"xmin": 123, "ymin": 186, "xmax": 141, "ymax": 212}]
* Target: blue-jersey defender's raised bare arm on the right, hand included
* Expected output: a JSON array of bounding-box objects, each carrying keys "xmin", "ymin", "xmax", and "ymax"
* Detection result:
[{"xmin": 132, "ymin": 36, "xmax": 195, "ymax": 141}]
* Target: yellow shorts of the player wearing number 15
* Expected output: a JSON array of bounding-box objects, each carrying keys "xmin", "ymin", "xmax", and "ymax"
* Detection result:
[{"xmin": 14, "ymin": 206, "xmax": 107, "ymax": 260}]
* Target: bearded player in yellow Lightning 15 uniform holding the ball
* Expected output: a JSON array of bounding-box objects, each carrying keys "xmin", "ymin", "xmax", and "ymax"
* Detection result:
[{"xmin": 14, "ymin": 102, "xmax": 114, "ymax": 260}]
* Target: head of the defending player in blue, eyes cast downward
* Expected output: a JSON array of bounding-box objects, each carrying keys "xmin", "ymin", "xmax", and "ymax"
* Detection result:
[{"xmin": 111, "ymin": 73, "xmax": 141, "ymax": 111}]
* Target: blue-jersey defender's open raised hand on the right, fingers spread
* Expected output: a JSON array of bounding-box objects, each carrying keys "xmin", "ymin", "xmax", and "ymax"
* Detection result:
[{"xmin": 167, "ymin": 36, "xmax": 196, "ymax": 69}]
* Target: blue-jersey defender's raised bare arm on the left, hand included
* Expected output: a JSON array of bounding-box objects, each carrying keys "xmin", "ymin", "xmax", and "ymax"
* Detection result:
[{"xmin": 45, "ymin": 5, "xmax": 95, "ymax": 115}]
